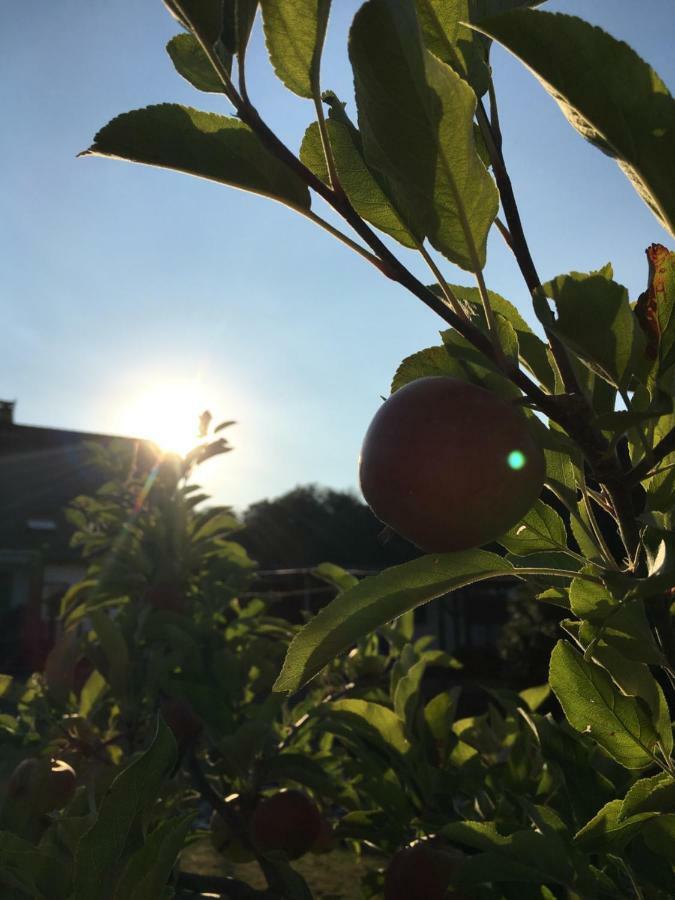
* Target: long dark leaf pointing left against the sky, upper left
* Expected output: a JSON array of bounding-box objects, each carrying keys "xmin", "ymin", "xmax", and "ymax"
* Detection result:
[{"xmin": 80, "ymin": 103, "xmax": 310, "ymax": 209}]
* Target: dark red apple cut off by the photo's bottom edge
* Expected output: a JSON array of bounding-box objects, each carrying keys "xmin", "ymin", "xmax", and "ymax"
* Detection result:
[{"xmin": 384, "ymin": 844, "xmax": 462, "ymax": 900}]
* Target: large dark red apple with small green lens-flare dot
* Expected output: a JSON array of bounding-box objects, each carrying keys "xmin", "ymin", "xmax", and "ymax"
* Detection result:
[{"xmin": 360, "ymin": 376, "xmax": 546, "ymax": 553}]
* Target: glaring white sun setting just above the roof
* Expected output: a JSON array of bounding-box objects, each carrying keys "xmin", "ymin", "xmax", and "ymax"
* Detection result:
[{"xmin": 123, "ymin": 380, "xmax": 209, "ymax": 456}]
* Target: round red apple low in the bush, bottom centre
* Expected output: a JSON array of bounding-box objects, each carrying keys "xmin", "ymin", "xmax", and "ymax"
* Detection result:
[{"xmin": 251, "ymin": 791, "xmax": 321, "ymax": 859}]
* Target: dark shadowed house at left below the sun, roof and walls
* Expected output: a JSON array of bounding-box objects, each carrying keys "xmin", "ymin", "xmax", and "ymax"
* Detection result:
[{"xmin": 0, "ymin": 400, "xmax": 157, "ymax": 672}]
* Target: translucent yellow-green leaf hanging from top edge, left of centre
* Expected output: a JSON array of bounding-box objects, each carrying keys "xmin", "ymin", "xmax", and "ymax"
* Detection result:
[{"xmin": 260, "ymin": 0, "xmax": 330, "ymax": 98}]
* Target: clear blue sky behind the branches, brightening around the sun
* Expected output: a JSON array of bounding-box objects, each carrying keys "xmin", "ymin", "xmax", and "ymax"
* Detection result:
[{"xmin": 0, "ymin": 0, "xmax": 675, "ymax": 508}]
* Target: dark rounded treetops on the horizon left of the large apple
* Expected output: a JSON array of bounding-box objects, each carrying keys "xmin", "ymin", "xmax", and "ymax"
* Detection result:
[{"xmin": 238, "ymin": 485, "xmax": 419, "ymax": 569}]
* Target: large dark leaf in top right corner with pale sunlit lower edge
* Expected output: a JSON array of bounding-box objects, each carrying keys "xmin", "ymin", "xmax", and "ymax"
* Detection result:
[{"xmin": 476, "ymin": 10, "xmax": 675, "ymax": 234}]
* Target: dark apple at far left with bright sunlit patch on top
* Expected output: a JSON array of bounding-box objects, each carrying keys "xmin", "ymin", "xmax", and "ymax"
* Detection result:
[{"xmin": 7, "ymin": 758, "xmax": 77, "ymax": 815}]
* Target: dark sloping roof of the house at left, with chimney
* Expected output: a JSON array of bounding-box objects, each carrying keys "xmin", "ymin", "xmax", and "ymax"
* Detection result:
[{"xmin": 0, "ymin": 401, "xmax": 157, "ymax": 562}]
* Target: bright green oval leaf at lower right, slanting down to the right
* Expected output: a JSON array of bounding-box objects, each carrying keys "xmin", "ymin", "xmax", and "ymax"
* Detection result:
[{"xmin": 549, "ymin": 641, "xmax": 658, "ymax": 769}]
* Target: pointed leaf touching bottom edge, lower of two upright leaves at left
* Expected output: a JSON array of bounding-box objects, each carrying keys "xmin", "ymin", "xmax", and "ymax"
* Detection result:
[{"xmin": 115, "ymin": 813, "xmax": 194, "ymax": 900}]
